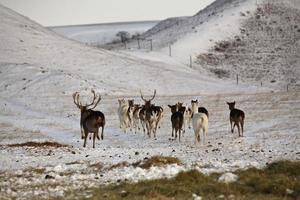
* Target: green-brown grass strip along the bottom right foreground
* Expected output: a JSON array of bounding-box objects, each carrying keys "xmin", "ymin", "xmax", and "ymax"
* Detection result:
[{"xmin": 84, "ymin": 161, "xmax": 300, "ymax": 200}]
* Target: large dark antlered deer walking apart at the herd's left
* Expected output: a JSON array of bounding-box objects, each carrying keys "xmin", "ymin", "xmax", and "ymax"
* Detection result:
[{"xmin": 73, "ymin": 90, "xmax": 105, "ymax": 148}]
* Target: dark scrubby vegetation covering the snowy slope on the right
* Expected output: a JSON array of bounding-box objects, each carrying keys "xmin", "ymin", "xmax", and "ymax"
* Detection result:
[{"xmin": 197, "ymin": 1, "xmax": 300, "ymax": 87}]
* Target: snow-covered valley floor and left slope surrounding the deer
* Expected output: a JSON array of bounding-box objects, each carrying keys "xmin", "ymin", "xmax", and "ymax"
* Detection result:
[{"xmin": 0, "ymin": 1, "xmax": 300, "ymax": 198}]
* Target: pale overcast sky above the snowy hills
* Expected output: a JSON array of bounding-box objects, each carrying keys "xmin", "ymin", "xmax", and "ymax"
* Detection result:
[{"xmin": 0, "ymin": 0, "xmax": 214, "ymax": 26}]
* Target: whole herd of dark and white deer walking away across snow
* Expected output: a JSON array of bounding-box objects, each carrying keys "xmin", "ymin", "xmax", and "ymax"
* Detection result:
[{"xmin": 73, "ymin": 90, "xmax": 245, "ymax": 148}]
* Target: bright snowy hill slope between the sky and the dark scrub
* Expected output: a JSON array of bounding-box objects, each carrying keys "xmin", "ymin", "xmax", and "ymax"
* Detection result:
[{"xmin": 124, "ymin": 0, "xmax": 256, "ymax": 51}]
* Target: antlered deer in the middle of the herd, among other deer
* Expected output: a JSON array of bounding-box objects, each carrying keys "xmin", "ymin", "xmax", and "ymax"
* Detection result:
[{"xmin": 140, "ymin": 90, "xmax": 158, "ymax": 138}]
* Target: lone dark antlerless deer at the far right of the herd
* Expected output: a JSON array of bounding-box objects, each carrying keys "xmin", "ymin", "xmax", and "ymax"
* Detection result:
[{"xmin": 226, "ymin": 101, "xmax": 245, "ymax": 137}]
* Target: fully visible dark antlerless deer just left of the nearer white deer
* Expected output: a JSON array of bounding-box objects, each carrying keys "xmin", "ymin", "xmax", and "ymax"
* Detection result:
[{"xmin": 168, "ymin": 104, "xmax": 183, "ymax": 142}]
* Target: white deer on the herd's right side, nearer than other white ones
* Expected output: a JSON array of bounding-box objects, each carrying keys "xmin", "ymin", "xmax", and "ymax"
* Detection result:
[{"xmin": 192, "ymin": 101, "xmax": 208, "ymax": 144}]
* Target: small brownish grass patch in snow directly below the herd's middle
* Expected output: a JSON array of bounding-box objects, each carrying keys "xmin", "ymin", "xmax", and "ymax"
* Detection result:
[{"xmin": 133, "ymin": 156, "xmax": 182, "ymax": 169}]
